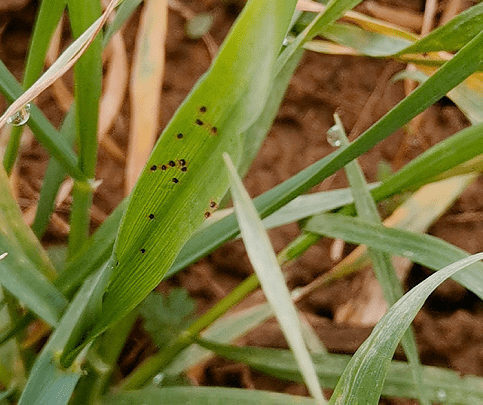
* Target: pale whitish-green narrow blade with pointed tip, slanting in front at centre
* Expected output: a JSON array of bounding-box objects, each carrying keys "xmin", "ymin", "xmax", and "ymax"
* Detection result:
[{"xmin": 223, "ymin": 154, "xmax": 325, "ymax": 404}]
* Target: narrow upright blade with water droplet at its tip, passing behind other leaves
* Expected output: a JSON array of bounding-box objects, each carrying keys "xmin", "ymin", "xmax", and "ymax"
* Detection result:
[{"xmin": 334, "ymin": 115, "xmax": 429, "ymax": 405}]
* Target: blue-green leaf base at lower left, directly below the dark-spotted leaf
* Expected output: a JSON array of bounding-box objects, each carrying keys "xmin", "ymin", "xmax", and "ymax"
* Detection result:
[{"xmin": 18, "ymin": 267, "xmax": 110, "ymax": 405}]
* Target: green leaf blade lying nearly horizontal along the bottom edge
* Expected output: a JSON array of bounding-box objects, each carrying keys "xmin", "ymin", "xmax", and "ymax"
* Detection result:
[{"xmin": 103, "ymin": 387, "xmax": 314, "ymax": 405}]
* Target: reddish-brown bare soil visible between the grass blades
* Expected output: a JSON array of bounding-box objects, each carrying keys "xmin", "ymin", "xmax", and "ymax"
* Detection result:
[{"xmin": 0, "ymin": 0, "xmax": 483, "ymax": 404}]
